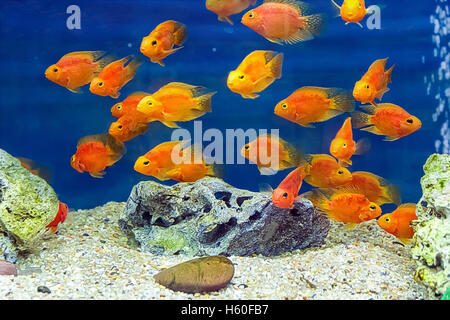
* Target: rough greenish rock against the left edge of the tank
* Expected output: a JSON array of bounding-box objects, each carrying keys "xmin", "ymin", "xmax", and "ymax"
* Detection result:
[{"xmin": 0, "ymin": 149, "xmax": 59, "ymax": 262}]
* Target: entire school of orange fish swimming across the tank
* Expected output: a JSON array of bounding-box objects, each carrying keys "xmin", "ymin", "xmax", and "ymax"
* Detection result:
[{"xmin": 32, "ymin": 0, "xmax": 421, "ymax": 243}]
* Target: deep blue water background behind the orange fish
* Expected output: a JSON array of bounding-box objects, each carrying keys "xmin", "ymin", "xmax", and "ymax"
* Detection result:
[{"xmin": 0, "ymin": 0, "xmax": 440, "ymax": 208}]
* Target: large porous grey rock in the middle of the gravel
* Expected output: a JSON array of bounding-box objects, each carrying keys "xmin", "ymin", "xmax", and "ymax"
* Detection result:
[{"xmin": 119, "ymin": 177, "xmax": 330, "ymax": 256}]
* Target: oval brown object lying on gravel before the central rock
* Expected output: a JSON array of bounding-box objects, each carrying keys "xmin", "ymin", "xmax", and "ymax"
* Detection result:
[{"xmin": 154, "ymin": 256, "xmax": 234, "ymax": 293}]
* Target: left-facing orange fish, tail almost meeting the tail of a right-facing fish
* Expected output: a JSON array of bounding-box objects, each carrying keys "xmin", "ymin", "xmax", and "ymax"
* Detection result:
[{"xmin": 275, "ymin": 87, "xmax": 355, "ymax": 128}]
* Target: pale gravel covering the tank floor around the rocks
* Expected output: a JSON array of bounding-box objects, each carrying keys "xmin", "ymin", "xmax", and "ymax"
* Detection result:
[{"xmin": 0, "ymin": 202, "xmax": 429, "ymax": 300}]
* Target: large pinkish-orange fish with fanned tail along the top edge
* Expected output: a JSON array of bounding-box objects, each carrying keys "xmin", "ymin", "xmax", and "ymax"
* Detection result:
[{"xmin": 241, "ymin": 0, "xmax": 324, "ymax": 44}]
